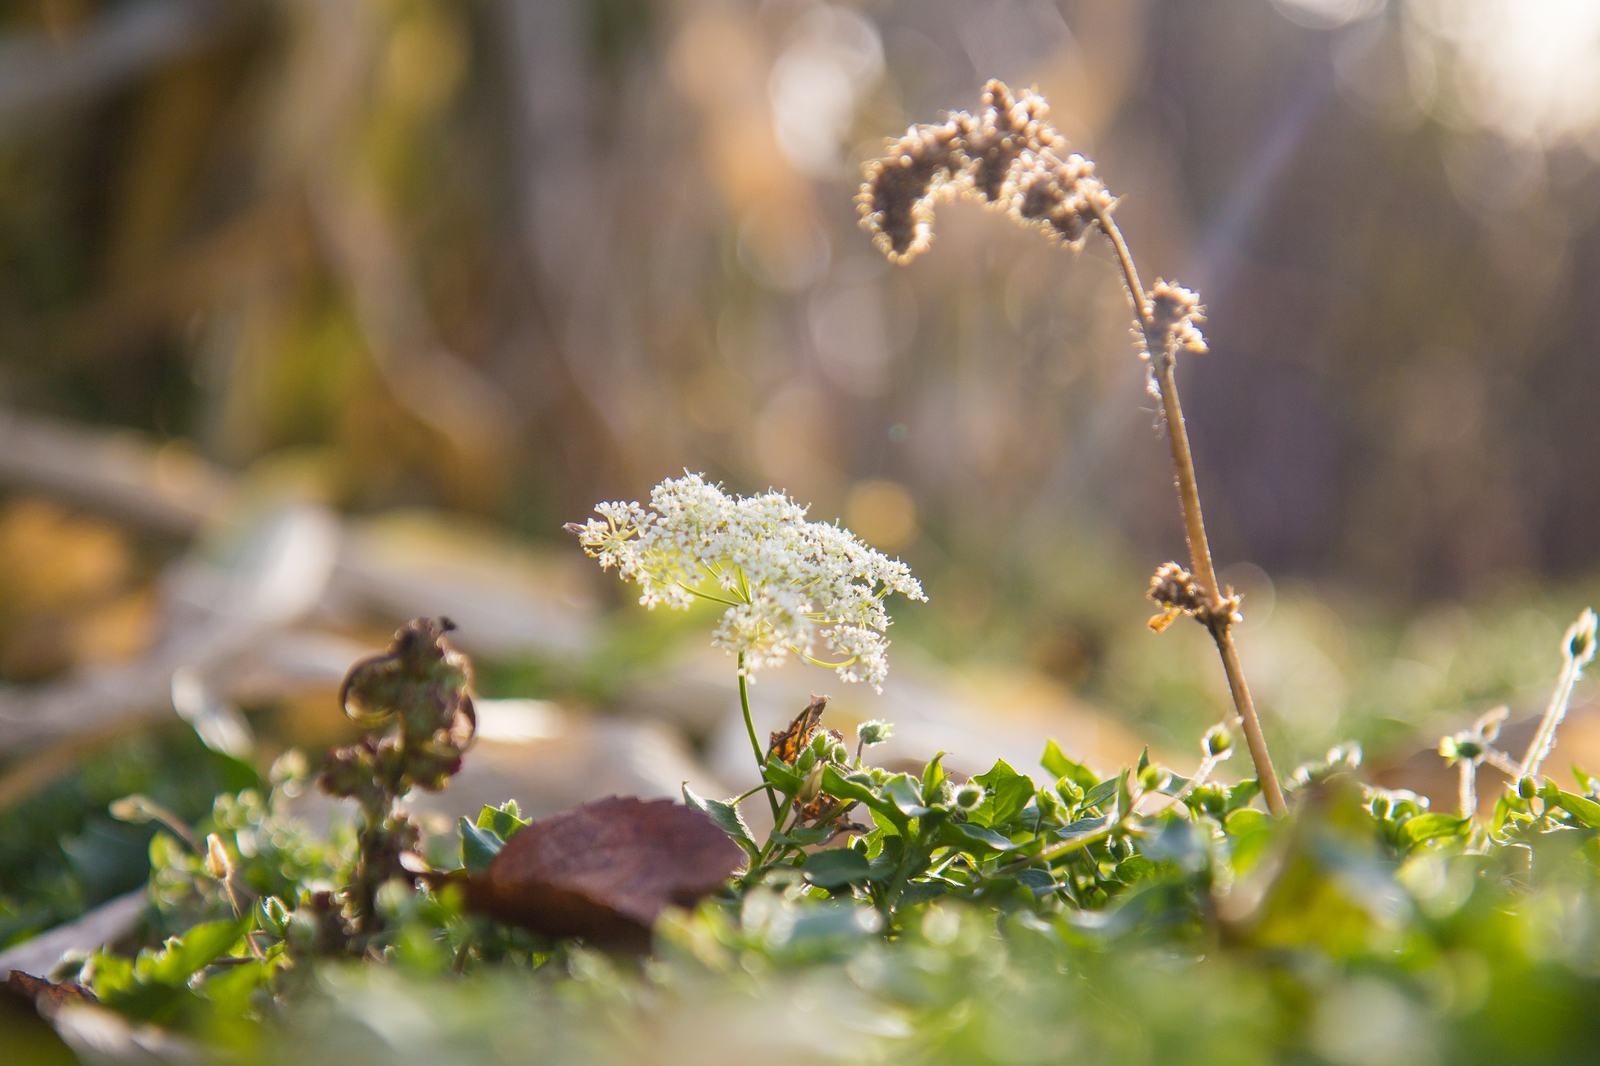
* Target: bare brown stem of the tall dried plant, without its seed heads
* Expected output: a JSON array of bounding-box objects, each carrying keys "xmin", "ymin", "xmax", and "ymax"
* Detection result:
[{"xmin": 1093, "ymin": 203, "xmax": 1288, "ymax": 815}]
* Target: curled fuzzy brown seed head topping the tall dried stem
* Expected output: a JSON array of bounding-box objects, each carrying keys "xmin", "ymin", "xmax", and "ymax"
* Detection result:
[{"xmin": 856, "ymin": 82, "xmax": 1112, "ymax": 262}]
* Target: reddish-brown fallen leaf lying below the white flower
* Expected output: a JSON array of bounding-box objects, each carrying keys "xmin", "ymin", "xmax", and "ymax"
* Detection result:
[{"xmin": 466, "ymin": 795, "xmax": 744, "ymax": 951}]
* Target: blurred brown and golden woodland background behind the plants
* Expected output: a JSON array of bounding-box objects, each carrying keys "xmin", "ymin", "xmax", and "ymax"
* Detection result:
[{"xmin": 0, "ymin": 0, "xmax": 1600, "ymax": 944}]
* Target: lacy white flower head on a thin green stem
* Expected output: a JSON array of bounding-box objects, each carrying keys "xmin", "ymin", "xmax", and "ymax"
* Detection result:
[{"xmin": 566, "ymin": 474, "xmax": 926, "ymax": 687}]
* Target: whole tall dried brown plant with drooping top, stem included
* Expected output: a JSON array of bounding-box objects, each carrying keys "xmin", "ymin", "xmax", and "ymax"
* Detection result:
[{"xmin": 858, "ymin": 82, "xmax": 1288, "ymax": 815}]
